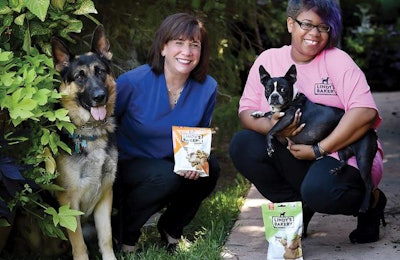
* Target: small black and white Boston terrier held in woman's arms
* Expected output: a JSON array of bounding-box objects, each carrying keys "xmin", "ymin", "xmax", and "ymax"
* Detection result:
[{"xmin": 253, "ymin": 65, "xmax": 378, "ymax": 212}]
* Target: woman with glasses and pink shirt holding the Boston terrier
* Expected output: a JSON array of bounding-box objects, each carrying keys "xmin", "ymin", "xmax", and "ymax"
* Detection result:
[{"xmin": 230, "ymin": 0, "xmax": 386, "ymax": 243}]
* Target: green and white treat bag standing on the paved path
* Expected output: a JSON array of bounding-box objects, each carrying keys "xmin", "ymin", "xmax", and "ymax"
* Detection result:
[{"xmin": 261, "ymin": 201, "xmax": 303, "ymax": 260}]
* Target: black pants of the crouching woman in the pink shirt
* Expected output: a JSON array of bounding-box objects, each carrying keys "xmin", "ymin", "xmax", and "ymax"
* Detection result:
[{"xmin": 229, "ymin": 130, "xmax": 365, "ymax": 215}]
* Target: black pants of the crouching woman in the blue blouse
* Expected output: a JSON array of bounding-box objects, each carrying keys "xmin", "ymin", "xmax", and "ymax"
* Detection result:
[{"xmin": 112, "ymin": 154, "xmax": 220, "ymax": 245}]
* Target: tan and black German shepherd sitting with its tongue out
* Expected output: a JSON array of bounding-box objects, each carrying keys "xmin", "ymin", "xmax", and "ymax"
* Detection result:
[{"xmin": 52, "ymin": 25, "xmax": 118, "ymax": 260}]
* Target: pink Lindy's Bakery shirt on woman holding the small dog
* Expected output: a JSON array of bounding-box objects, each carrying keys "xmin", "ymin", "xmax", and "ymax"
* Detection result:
[{"xmin": 239, "ymin": 46, "xmax": 383, "ymax": 187}]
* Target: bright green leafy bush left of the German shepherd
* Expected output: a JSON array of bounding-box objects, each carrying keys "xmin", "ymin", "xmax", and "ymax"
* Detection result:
[{"xmin": 0, "ymin": 0, "xmax": 97, "ymax": 239}]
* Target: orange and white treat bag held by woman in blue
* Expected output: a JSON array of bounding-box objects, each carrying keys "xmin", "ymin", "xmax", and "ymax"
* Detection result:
[{"xmin": 172, "ymin": 126, "xmax": 212, "ymax": 177}]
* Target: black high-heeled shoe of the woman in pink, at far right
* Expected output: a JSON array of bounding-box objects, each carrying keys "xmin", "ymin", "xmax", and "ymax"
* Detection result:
[{"xmin": 349, "ymin": 189, "xmax": 387, "ymax": 244}]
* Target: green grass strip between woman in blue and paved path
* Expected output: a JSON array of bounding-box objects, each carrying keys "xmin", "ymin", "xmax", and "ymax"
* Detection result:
[{"xmin": 112, "ymin": 175, "xmax": 250, "ymax": 260}]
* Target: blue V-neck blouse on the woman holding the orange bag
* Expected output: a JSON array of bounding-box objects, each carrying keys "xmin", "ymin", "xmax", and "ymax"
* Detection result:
[{"xmin": 115, "ymin": 64, "xmax": 217, "ymax": 160}]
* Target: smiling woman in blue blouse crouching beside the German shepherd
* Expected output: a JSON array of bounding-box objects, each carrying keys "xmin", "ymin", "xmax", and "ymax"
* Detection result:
[{"xmin": 113, "ymin": 13, "xmax": 220, "ymax": 252}]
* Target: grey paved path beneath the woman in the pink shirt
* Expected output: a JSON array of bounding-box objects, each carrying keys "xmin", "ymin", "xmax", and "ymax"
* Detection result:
[{"xmin": 222, "ymin": 92, "xmax": 400, "ymax": 260}]
